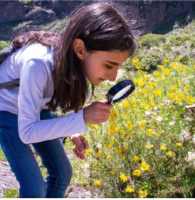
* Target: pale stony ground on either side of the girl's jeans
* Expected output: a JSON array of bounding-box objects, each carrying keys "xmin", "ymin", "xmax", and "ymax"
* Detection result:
[{"xmin": 0, "ymin": 161, "xmax": 92, "ymax": 198}]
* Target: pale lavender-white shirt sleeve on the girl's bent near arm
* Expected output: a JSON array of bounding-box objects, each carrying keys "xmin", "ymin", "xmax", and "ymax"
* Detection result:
[{"xmin": 18, "ymin": 60, "xmax": 87, "ymax": 143}]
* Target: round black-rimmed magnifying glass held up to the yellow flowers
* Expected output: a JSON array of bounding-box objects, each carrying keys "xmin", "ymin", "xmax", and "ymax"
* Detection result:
[{"xmin": 106, "ymin": 80, "xmax": 135, "ymax": 104}]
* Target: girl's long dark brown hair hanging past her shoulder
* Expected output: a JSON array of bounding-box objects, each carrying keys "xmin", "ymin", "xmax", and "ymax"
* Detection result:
[{"xmin": 11, "ymin": 3, "xmax": 136, "ymax": 112}]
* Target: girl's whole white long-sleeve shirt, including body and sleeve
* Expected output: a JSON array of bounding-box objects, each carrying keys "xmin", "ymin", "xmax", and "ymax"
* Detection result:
[{"xmin": 0, "ymin": 44, "xmax": 87, "ymax": 143}]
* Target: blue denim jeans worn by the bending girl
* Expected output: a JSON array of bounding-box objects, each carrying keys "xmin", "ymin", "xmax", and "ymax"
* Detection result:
[{"xmin": 0, "ymin": 110, "xmax": 72, "ymax": 198}]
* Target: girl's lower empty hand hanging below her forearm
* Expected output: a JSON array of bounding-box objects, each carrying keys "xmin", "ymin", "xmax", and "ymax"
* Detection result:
[{"xmin": 70, "ymin": 133, "xmax": 88, "ymax": 159}]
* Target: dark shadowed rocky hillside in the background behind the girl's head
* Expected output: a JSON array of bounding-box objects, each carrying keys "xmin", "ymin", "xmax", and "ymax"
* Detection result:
[{"xmin": 0, "ymin": 0, "xmax": 195, "ymax": 40}]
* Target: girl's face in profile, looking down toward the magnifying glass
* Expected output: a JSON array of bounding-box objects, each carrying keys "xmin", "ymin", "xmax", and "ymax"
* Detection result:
[{"xmin": 82, "ymin": 50, "xmax": 129, "ymax": 86}]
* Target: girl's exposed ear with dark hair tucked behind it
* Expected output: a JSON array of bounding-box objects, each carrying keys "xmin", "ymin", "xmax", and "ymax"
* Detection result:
[{"xmin": 73, "ymin": 38, "xmax": 86, "ymax": 60}]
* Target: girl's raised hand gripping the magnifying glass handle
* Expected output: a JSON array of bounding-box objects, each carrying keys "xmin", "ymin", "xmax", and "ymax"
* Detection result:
[{"xmin": 83, "ymin": 99, "xmax": 112, "ymax": 124}]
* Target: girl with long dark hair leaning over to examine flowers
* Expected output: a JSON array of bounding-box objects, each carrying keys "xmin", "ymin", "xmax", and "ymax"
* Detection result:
[{"xmin": 0, "ymin": 3, "xmax": 136, "ymax": 198}]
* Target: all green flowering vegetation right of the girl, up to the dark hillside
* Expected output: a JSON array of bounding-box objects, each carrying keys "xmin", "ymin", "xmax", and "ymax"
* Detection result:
[{"xmin": 0, "ymin": 17, "xmax": 195, "ymax": 198}]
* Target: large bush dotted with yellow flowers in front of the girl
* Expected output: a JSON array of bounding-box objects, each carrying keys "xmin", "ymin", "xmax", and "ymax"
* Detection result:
[{"xmin": 76, "ymin": 59, "xmax": 195, "ymax": 198}]
